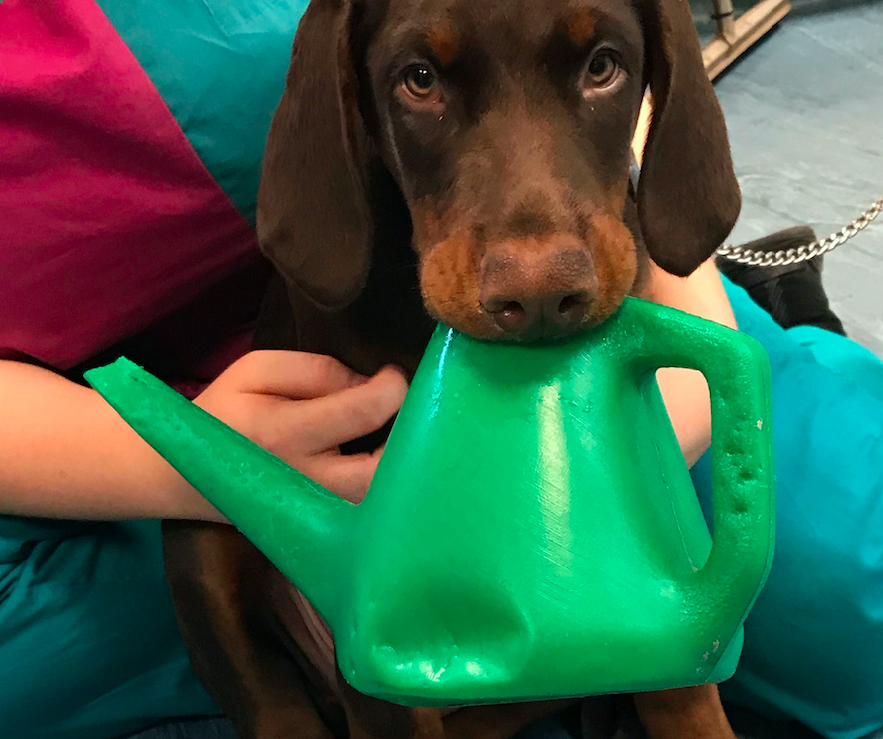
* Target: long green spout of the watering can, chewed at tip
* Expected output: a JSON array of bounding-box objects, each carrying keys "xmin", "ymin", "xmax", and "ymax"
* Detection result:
[{"xmin": 86, "ymin": 358, "xmax": 356, "ymax": 615}]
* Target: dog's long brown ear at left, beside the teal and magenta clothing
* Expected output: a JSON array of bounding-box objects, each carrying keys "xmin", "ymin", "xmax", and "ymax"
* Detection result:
[{"xmin": 257, "ymin": 0, "xmax": 374, "ymax": 308}]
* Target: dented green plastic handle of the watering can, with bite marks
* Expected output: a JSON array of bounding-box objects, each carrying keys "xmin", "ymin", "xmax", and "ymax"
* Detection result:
[{"xmin": 621, "ymin": 298, "xmax": 774, "ymax": 612}]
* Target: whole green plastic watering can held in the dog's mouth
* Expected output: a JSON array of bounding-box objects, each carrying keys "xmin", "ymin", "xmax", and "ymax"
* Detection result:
[{"xmin": 87, "ymin": 299, "xmax": 773, "ymax": 706}]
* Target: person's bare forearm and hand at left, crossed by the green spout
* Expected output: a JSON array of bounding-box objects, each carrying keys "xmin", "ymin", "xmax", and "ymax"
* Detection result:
[{"xmin": 0, "ymin": 352, "xmax": 406, "ymax": 521}]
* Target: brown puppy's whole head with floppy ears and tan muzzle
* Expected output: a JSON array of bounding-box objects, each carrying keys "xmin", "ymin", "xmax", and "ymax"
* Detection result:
[{"xmin": 258, "ymin": 0, "xmax": 740, "ymax": 340}]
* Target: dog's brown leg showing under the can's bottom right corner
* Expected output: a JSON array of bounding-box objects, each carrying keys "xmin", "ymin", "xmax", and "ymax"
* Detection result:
[{"xmin": 635, "ymin": 685, "xmax": 736, "ymax": 739}]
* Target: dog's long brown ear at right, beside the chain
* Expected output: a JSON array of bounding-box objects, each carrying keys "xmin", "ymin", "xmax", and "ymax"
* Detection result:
[{"xmin": 638, "ymin": 0, "xmax": 742, "ymax": 276}]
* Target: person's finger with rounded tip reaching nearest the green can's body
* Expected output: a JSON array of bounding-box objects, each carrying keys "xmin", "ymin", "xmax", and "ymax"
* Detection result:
[{"xmin": 296, "ymin": 367, "xmax": 408, "ymax": 452}]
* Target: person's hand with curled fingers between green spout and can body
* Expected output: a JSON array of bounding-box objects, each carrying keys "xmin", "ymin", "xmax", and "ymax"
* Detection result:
[{"xmin": 195, "ymin": 351, "xmax": 408, "ymax": 502}]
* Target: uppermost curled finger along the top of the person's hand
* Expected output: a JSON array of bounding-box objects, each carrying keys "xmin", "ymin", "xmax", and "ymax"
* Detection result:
[{"xmin": 225, "ymin": 349, "xmax": 368, "ymax": 400}]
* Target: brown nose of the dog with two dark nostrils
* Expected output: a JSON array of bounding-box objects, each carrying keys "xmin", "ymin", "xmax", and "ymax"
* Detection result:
[{"xmin": 479, "ymin": 244, "xmax": 595, "ymax": 339}]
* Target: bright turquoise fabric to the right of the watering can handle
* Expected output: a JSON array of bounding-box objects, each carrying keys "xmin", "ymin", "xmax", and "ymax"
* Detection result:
[{"xmin": 693, "ymin": 282, "xmax": 883, "ymax": 739}]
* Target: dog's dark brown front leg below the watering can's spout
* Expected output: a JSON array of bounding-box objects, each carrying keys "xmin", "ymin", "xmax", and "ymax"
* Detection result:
[{"xmin": 163, "ymin": 521, "xmax": 332, "ymax": 739}]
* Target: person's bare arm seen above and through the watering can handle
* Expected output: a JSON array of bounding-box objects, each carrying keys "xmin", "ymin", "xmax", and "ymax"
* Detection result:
[{"xmin": 641, "ymin": 260, "xmax": 736, "ymax": 467}]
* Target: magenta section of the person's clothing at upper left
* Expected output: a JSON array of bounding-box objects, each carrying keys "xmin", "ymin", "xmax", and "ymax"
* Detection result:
[{"xmin": 0, "ymin": 0, "xmax": 267, "ymax": 394}]
